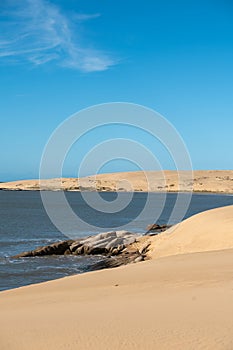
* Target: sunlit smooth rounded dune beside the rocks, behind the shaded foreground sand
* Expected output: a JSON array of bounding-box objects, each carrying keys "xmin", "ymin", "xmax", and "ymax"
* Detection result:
[{"xmin": 150, "ymin": 206, "xmax": 233, "ymax": 258}]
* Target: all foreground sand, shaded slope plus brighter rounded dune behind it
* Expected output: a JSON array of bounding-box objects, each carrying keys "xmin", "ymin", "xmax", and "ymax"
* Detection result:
[{"xmin": 0, "ymin": 206, "xmax": 233, "ymax": 350}]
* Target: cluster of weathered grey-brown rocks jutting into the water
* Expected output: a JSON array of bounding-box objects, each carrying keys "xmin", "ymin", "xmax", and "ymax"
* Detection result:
[{"xmin": 14, "ymin": 231, "xmax": 150, "ymax": 270}]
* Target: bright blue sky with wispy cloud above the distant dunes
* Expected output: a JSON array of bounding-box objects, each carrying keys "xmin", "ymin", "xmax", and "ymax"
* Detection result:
[{"xmin": 0, "ymin": 0, "xmax": 233, "ymax": 181}]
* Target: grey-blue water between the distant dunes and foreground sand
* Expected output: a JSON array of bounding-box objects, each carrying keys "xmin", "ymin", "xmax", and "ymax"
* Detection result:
[{"xmin": 0, "ymin": 191, "xmax": 233, "ymax": 290}]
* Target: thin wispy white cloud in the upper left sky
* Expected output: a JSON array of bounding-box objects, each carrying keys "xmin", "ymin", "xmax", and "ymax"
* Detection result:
[{"xmin": 0, "ymin": 0, "xmax": 116, "ymax": 72}]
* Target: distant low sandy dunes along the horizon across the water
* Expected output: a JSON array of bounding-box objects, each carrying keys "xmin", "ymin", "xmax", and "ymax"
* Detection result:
[{"xmin": 0, "ymin": 170, "xmax": 233, "ymax": 193}]
